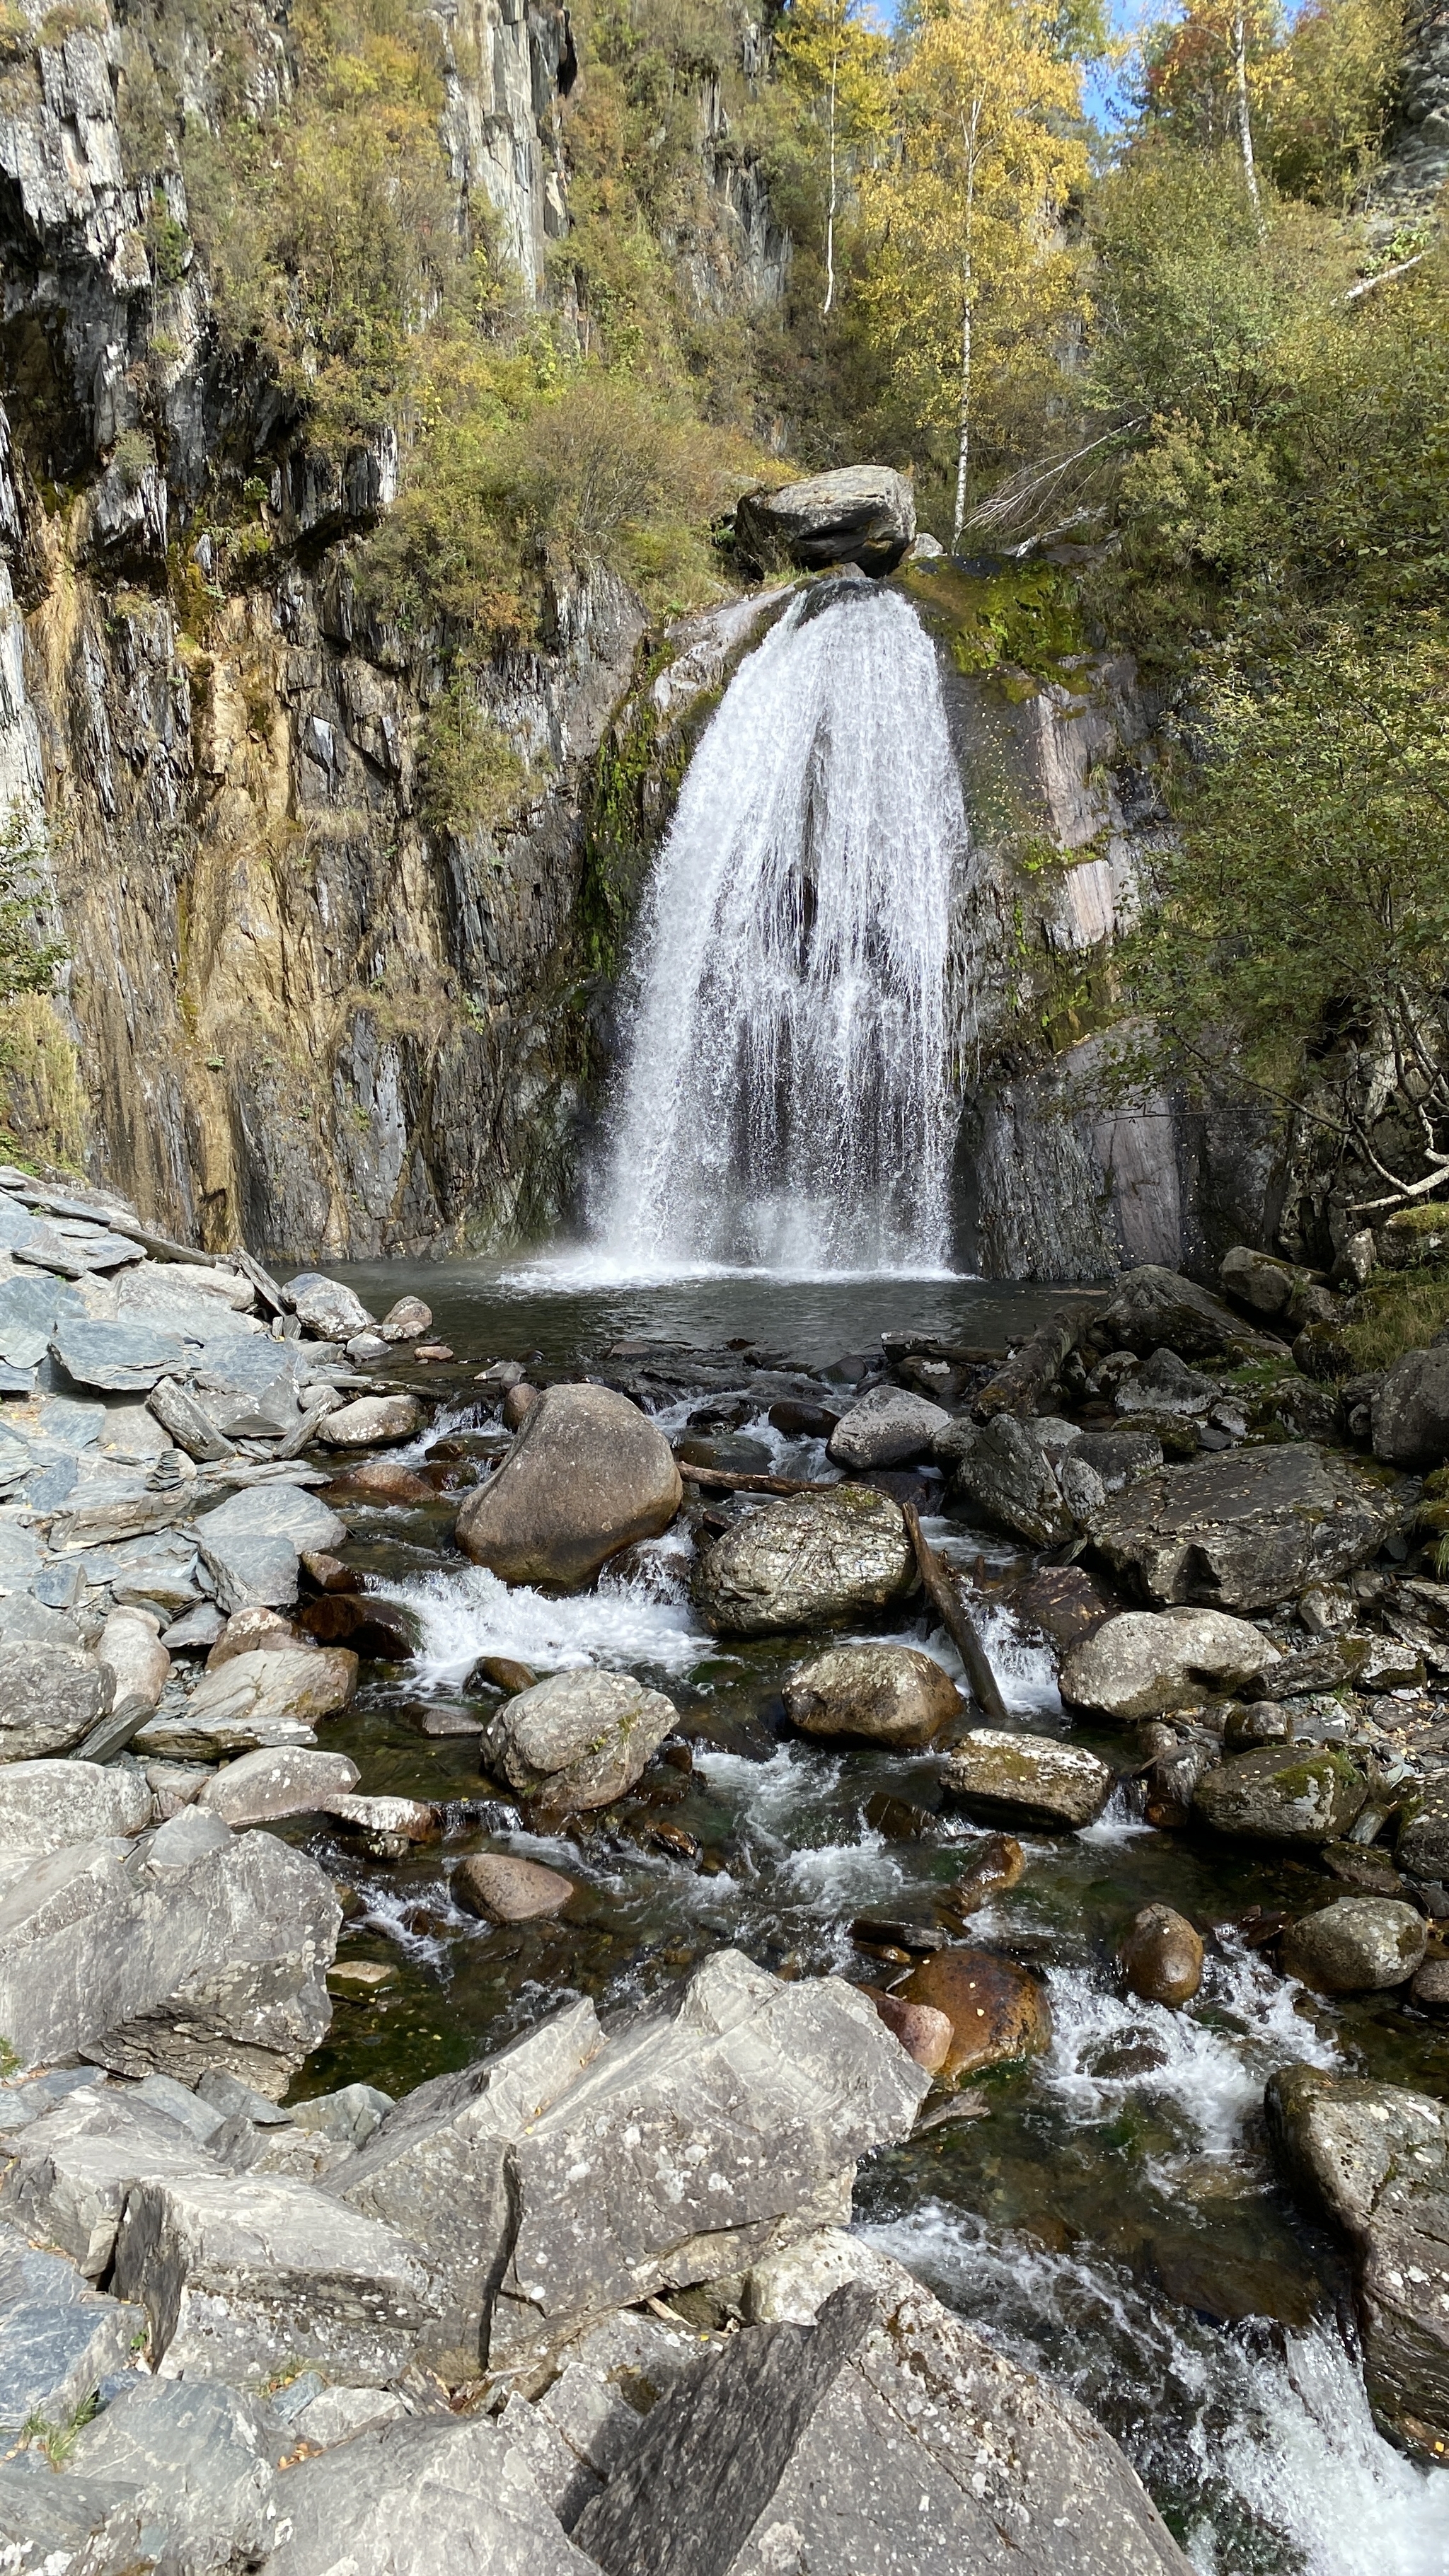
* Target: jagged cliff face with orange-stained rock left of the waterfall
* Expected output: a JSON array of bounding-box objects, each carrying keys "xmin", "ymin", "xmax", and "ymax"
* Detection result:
[{"xmin": 0, "ymin": 0, "xmax": 784, "ymax": 1257}]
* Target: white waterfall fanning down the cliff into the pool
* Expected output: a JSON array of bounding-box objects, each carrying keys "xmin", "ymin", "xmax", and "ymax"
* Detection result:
[{"xmin": 593, "ymin": 582, "xmax": 967, "ymax": 1278}]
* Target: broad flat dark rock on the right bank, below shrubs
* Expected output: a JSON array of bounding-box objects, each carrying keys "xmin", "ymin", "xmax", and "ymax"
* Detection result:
[{"xmin": 1090, "ymin": 1440, "xmax": 1402, "ymax": 1610}]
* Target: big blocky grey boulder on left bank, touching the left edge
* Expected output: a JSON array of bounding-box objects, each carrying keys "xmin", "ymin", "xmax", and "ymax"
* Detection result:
[{"xmin": 0, "ymin": 1819, "xmax": 340, "ymax": 2094}]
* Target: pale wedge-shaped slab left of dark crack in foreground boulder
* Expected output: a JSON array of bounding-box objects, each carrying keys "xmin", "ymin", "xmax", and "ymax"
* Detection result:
[{"xmin": 333, "ymin": 2002, "xmax": 604, "ymax": 2383}]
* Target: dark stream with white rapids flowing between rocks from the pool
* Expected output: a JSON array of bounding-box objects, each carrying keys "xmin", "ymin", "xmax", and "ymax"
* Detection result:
[{"xmin": 265, "ymin": 1252, "xmax": 1449, "ymax": 2576}]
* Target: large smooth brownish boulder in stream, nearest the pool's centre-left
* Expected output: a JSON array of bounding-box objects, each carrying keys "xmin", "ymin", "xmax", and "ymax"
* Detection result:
[{"xmin": 456, "ymin": 1386, "xmax": 683, "ymax": 1584}]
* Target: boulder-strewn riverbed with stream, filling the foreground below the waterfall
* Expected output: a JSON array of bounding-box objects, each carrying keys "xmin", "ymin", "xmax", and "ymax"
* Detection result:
[{"xmin": 0, "ymin": 1195, "xmax": 1449, "ymax": 2576}]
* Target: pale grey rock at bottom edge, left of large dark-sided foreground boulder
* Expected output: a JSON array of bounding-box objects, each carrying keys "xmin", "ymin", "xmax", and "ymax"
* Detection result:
[{"xmin": 265, "ymin": 2416, "xmax": 598, "ymax": 2576}]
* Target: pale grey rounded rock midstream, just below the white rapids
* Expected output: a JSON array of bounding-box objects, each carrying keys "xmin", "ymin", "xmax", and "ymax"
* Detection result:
[{"xmin": 495, "ymin": 1672, "xmax": 678, "ymax": 1816}]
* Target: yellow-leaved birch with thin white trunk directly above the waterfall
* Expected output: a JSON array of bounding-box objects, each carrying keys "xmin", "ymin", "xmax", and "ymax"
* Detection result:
[{"xmin": 861, "ymin": 0, "xmax": 1088, "ymax": 546}]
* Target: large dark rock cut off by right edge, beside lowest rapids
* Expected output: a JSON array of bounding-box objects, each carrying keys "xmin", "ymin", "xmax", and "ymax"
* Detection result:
[{"xmin": 1264, "ymin": 2066, "xmax": 1449, "ymax": 2458}]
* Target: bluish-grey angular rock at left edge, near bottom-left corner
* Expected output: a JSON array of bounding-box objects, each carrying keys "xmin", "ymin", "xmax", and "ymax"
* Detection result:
[{"xmin": 0, "ymin": 2226, "xmax": 144, "ymax": 2444}]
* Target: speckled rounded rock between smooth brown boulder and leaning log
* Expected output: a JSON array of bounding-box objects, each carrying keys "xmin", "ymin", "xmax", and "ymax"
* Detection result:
[{"xmin": 696, "ymin": 1484, "xmax": 916, "ymax": 1636}]
